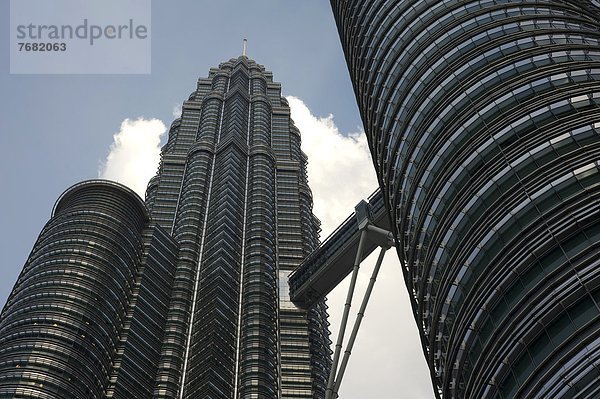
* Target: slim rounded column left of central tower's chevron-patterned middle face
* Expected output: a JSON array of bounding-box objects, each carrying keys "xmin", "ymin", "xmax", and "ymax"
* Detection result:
[{"xmin": 158, "ymin": 93, "xmax": 226, "ymax": 398}]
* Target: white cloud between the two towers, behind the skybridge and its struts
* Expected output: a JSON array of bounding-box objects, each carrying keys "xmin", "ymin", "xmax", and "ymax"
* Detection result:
[{"xmin": 287, "ymin": 97, "xmax": 434, "ymax": 399}]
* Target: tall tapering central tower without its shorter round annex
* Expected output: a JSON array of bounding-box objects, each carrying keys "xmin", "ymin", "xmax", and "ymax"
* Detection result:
[{"xmin": 146, "ymin": 56, "xmax": 330, "ymax": 398}]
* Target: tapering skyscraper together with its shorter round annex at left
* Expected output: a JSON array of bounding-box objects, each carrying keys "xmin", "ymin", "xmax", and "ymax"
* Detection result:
[{"xmin": 0, "ymin": 55, "xmax": 330, "ymax": 398}]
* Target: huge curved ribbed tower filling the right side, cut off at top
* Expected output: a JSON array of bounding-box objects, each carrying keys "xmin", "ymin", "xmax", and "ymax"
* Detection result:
[{"xmin": 331, "ymin": 0, "xmax": 600, "ymax": 398}]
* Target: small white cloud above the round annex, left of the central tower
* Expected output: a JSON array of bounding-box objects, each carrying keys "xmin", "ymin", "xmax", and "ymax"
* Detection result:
[{"xmin": 98, "ymin": 118, "xmax": 167, "ymax": 198}]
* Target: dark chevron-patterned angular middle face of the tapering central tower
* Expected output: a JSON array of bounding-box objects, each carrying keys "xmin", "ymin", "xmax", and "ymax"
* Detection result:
[{"xmin": 182, "ymin": 62, "xmax": 250, "ymax": 398}]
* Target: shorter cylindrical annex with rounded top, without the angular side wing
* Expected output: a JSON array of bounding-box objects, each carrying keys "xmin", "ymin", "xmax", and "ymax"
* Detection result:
[{"xmin": 0, "ymin": 180, "xmax": 148, "ymax": 399}]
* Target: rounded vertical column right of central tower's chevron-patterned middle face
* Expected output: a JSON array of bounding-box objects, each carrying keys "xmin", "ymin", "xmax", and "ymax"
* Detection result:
[{"xmin": 238, "ymin": 146, "xmax": 278, "ymax": 398}]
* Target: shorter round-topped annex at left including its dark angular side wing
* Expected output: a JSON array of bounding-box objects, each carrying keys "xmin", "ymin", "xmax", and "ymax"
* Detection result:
[{"xmin": 0, "ymin": 180, "xmax": 176, "ymax": 399}]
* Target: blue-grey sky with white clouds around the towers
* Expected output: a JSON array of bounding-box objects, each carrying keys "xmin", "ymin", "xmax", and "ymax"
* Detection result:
[{"xmin": 0, "ymin": 0, "xmax": 434, "ymax": 399}]
